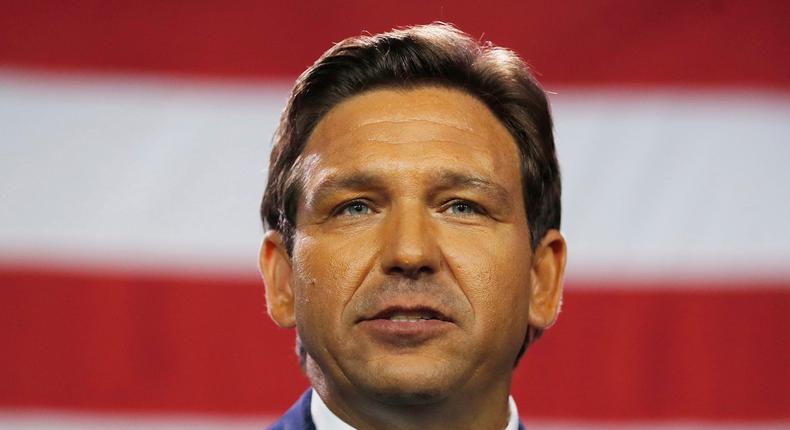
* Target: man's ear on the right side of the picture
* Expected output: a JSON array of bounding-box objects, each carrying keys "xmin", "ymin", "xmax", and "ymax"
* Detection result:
[{"xmin": 529, "ymin": 230, "xmax": 567, "ymax": 329}]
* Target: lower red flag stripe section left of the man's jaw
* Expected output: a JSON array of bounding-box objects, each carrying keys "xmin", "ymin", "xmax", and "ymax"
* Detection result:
[{"xmin": 0, "ymin": 269, "xmax": 307, "ymax": 413}]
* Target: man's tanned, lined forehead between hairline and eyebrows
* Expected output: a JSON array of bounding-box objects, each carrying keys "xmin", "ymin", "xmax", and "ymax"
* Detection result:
[{"xmin": 303, "ymin": 87, "xmax": 520, "ymax": 188}]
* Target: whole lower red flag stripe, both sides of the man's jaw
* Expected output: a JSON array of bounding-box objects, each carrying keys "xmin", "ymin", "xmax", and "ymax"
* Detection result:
[{"xmin": 0, "ymin": 267, "xmax": 790, "ymax": 420}]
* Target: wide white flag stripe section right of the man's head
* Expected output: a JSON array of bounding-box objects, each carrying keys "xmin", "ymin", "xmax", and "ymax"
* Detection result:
[{"xmin": 553, "ymin": 90, "xmax": 790, "ymax": 277}]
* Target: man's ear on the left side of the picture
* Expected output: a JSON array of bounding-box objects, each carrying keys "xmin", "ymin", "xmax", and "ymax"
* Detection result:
[{"xmin": 258, "ymin": 230, "xmax": 296, "ymax": 327}]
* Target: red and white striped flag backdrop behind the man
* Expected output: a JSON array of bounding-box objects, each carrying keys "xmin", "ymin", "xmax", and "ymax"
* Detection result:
[{"xmin": 0, "ymin": 0, "xmax": 790, "ymax": 429}]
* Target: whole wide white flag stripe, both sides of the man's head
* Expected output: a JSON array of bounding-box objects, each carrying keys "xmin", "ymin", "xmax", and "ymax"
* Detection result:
[{"xmin": 0, "ymin": 71, "xmax": 790, "ymax": 278}]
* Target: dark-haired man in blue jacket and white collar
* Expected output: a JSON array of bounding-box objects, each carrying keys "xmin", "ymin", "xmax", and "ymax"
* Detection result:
[{"xmin": 260, "ymin": 24, "xmax": 566, "ymax": 430}]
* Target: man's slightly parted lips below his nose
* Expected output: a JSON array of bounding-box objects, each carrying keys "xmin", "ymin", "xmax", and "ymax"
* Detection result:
[{"xmin": 357, "ymin": 306, "xmax": 456, "ymax": 346}]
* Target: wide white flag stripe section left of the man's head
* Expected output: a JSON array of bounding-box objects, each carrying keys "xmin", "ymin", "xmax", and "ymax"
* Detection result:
[{"xmin": 0, "ymin": 69, "xmax": 286, "ymax": 269}]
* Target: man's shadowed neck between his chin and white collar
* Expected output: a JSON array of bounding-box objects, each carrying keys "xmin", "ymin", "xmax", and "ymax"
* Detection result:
[{"xmin": 307, "ymin": 359, "xmax": 510, "ymax": 430}]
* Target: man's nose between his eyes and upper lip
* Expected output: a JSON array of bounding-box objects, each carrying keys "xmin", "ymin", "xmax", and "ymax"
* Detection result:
[{"xmin": 381, "ymin": 207, "xmax": 441, "ymax": 279}]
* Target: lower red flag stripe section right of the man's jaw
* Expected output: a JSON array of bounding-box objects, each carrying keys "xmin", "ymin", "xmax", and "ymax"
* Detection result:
[{"xmin": 513, "ymin": 282, "xmax": 790, "ymax": 420}]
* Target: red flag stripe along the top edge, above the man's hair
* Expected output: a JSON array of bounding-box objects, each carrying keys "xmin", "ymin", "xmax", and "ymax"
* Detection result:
[{"xmin": 0, "ymin": 0, "xmax": 790, "ymax": 88}]
